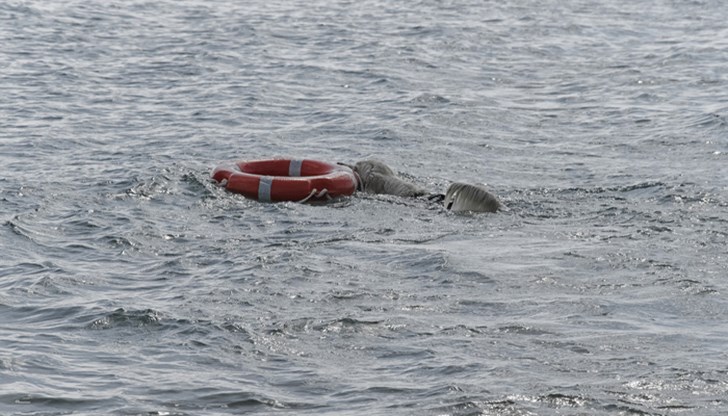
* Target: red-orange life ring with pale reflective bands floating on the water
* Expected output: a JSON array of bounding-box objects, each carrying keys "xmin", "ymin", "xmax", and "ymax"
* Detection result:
[{"xmin": 212, "ymin": 159, "xmax": 357, "ymax": 202}]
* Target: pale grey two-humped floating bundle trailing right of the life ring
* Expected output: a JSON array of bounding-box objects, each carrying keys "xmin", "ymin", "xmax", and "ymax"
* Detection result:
[{"xmin": 341, "ymin": 160, "xmax": 501, "ymax": 212}]
